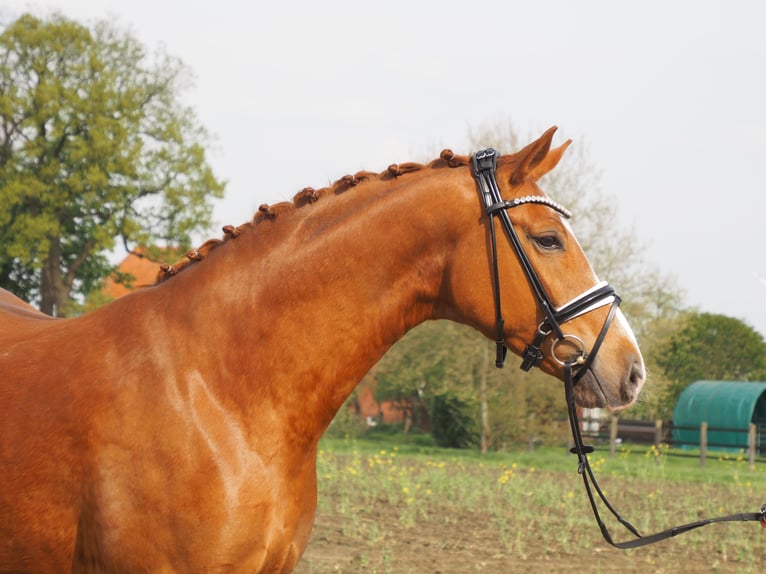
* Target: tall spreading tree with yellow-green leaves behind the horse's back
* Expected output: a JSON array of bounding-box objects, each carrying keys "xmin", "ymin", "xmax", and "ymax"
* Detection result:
[{"xmin": 0, "ymin": 15, "xmax": 224, "ymax": 315}]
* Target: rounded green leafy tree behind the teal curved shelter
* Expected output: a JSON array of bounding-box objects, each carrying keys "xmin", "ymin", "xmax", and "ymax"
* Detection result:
[{"xmin": 656, "ymin": 312, "xmax": 766, "ymax": 416}]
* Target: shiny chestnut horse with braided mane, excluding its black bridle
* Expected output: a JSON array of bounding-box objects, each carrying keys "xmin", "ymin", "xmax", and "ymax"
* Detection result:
[{"xmin": 0, "ymin": 128, "xmax": 644, "ymax": 572}]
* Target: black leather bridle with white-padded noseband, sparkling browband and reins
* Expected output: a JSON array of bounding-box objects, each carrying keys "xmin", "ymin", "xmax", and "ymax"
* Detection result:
[{"xmin": 472, "ymin": 148, "xmax": 766, "ymax": 549}]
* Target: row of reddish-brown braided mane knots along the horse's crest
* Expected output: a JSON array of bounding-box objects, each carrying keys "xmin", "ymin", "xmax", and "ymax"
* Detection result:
[{"xmin": 155, "ymin": 149, "xmax": 471, "ymax": 285}]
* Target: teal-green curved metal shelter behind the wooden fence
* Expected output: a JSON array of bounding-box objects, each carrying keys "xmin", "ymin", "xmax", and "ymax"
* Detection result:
[{"xmin": 673, "ymin": 381, "xmax": 766, "ymax": 450}]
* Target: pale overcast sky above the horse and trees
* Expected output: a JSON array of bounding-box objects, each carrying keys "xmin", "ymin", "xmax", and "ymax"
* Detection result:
[{"xmin": 0, "ymin": 0, "xmax": 766, "ymax": 340}]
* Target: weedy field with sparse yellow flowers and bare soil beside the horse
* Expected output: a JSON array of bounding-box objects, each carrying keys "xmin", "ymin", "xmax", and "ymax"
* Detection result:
[{"xmin": 296, "ymin": 437, "xmax": 766, "ymax": 574}]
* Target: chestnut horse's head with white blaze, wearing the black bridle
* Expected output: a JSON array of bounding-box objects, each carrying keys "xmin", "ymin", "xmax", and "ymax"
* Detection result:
[{"xmin": 445, "ymin": 128, "xmax": 645, "ymax": 409}]
